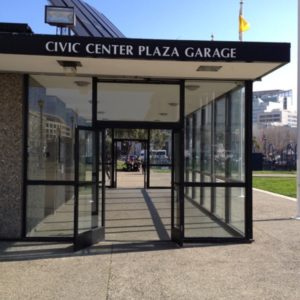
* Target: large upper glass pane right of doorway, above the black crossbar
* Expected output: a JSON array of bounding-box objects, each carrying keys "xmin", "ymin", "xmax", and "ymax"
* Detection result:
[{"xmin": 185, "ymin": 81, "xmax": 245, "ymax": 182}]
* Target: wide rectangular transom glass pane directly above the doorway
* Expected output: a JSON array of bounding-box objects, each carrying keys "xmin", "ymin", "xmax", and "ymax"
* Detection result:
[{"xmin": 97, "ymin": 82, "xmax": 180, "ymax": 122}]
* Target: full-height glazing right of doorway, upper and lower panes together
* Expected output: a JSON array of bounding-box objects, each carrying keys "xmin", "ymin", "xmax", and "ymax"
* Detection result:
[{"xmin": 184, "ymin": 81, "xmax": 245, "ymax": 237}]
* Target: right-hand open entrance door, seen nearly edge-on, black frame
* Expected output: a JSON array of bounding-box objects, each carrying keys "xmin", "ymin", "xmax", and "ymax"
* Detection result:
[{"xmin": 171, "ymin": 130, "xmax": 184, "ymax": 246}]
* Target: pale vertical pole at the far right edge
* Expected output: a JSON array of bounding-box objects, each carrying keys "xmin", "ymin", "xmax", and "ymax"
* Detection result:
[{"xmin": 294, "ymin": 1, "xmax": 300, "ymax": 220}]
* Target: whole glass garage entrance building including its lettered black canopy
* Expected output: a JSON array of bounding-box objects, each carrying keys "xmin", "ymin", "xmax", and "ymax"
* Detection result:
[{"xmin": 0, "ymin": 29, "xmax": 290, "ymax": 249}]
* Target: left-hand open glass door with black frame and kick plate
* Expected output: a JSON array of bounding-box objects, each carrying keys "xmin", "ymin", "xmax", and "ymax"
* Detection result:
[{"xmin": 74, "ymin": 127, "xmax": 105, "ymax": 251}]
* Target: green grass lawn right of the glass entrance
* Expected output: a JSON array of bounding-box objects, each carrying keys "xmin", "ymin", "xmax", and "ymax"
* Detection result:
[{"xmin": 253, "ymin": 177, "xmax": 297, "ymax": 198}]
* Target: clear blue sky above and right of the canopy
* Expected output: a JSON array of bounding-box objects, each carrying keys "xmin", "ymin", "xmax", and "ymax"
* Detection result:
[{"xmin": 0, "ymin": 0, "xmax": 297, "ymax": 93}]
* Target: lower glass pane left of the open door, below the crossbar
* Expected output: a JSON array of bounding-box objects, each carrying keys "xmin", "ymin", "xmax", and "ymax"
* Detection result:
[{"xmin": 26, "ymin": 185, "xmax": 74, "ymax": 237}]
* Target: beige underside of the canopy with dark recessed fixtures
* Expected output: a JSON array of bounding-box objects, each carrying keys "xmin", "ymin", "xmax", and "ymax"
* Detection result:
[{"xmin": 0, "ymin": 54, "xmax": 281, "ymax": 80}]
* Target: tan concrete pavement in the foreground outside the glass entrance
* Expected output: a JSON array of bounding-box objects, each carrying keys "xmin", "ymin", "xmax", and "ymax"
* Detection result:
[{"xmin": 0, "ymin": 191, "xmax": 300, "ymax": 300}]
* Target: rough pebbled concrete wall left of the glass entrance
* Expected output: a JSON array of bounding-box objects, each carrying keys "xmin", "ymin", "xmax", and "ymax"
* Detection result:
[{"xmin": 0, "ymin": 74, "xmax": 23, "ymax": 239}]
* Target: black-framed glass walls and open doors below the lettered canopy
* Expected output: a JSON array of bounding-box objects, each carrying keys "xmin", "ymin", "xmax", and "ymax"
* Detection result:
[{"xmin": 25, "ymin": 75, "xmax": 252, "ymax": 245}]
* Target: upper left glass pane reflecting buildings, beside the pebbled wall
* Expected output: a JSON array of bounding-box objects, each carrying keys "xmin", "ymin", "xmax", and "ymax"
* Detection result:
[{"xmin": 27, "ymin": 75, "xmax": 92, "ymax": 180}]
